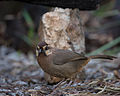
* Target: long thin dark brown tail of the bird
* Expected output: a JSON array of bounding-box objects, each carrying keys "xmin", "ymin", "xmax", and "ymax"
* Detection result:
[{"xmin": 89, "ymin": 55, "xmax": 117, "ymax": 60}]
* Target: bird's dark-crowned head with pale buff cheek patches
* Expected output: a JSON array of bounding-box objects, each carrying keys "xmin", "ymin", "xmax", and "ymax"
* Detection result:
[{"xmin": 36, "ymin": 41, "xmax": 51, "ymax": 57}]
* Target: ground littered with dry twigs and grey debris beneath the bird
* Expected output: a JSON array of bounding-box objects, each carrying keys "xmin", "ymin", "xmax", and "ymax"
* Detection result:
[{"xmin": 0, "ymin": 46, "xmax": 120, "ymax": 96}]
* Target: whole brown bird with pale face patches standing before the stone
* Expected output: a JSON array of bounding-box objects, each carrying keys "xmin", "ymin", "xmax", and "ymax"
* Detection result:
[{"xmin": 36, "ymin": 42, "xmax": 116, "ymax": 79}]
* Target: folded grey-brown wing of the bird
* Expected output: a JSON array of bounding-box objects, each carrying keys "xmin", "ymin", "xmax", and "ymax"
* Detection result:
[{"xmin": 53, "ymin": 49, "xmax": 88, "ymax": 65}]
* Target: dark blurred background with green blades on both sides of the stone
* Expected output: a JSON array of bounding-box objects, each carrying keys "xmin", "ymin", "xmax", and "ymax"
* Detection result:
[{"xmin": 0, "ymin": 0, "xmax": 120, "ymax": 54}]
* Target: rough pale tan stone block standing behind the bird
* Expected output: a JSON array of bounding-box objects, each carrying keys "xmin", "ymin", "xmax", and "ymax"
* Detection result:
[{"xmin": 39, "ymin": 8, "xmax": 85, "ymax": 82}]
